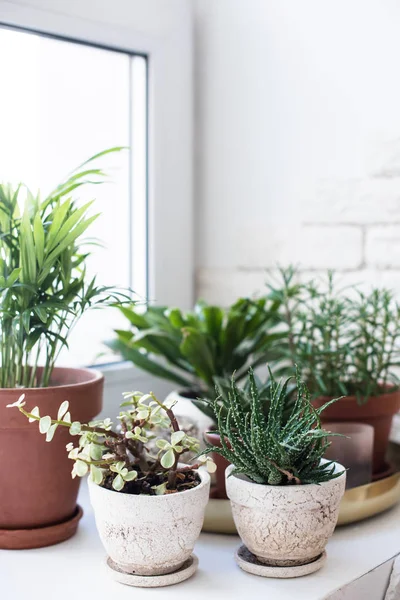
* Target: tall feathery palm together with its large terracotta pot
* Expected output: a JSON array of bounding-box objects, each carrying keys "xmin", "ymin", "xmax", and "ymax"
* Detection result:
[{"xmin": 0, "ymin": 149, "xmax": 126, "ymax": 548}]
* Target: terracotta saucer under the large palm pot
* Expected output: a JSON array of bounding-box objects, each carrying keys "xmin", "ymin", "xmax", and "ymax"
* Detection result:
[{"xmin": 0, "ymin": 505, "xmax": 83, "ymax": 550}]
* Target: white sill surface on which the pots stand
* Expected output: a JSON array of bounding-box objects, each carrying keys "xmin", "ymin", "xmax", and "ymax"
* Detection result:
[{"xmin": 0, "ymin": 483, "xmax": 400, "ymax": 600}]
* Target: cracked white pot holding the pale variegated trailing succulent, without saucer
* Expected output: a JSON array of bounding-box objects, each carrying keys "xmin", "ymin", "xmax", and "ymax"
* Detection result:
[{"xmin": 89, "ymin": 469, "xmax": 210, "ymax": 575}]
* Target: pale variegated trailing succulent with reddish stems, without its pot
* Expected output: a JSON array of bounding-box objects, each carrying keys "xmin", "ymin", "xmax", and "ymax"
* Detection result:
[{"xmin": 8, "ymin": 392, "xmax": 215, "ymax": 496}]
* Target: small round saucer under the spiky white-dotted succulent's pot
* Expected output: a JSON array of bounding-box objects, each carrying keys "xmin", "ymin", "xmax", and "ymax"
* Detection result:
[{"xmin": 235, "ymin": 544, "xmax": 326, "ymax": 579}]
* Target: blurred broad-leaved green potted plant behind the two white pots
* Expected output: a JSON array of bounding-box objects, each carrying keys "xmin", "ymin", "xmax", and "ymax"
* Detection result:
[{"xmin": 108, "ymin": 298, "xmax": 282, "ymax": 497}]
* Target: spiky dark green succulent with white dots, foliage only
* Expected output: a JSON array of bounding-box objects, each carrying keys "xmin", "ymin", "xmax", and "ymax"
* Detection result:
[{"xmin": 203, "ymin": 370, "xmax": 340, "ymax": 485}]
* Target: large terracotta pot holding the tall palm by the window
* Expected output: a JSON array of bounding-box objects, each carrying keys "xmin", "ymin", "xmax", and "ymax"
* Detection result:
[{"xmin": 0, "ymin": 368, "xmax": 103, "ymax": 548}]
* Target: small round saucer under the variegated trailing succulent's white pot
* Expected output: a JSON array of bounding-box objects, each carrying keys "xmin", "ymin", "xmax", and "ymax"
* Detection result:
[{"xmin": 106, "ymin": 554, "xmax": 199, "ymax": 587}]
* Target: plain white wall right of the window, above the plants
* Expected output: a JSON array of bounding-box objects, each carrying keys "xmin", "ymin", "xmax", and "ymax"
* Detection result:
[{"xmin": 195, "ymin": 0, "xmax": 400, "ymax": 303}]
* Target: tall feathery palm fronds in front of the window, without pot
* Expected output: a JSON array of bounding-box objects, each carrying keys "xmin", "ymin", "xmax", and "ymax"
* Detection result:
[{"xmin": 0, "ymin": 148, "xmax": 128, "ymax": 388}]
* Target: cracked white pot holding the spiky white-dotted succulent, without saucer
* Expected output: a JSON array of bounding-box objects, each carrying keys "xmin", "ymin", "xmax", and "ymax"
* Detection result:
[{"xmin": 226, "ymin": 463, "xmax": 346, "ymax": 567}]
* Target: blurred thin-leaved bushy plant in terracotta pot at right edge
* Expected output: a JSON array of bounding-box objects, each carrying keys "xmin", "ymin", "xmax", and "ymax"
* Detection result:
[{"xmin": 270, "ymin": 268, "xmax": 400, "ymax": 476}]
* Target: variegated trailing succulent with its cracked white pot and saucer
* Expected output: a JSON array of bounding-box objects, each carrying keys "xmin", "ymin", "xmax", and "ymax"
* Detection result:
[{"xmin": 9, "ymin": 392, "xmax": 213, "ymax": 587}]
